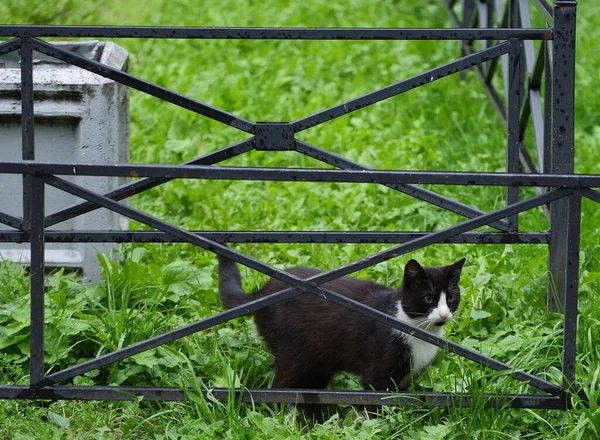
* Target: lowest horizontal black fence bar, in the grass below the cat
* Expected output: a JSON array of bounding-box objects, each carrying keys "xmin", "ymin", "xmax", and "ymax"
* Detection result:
[{"xmin": 0, "ymin": 385, "xmax": 567, "ymax": 409}]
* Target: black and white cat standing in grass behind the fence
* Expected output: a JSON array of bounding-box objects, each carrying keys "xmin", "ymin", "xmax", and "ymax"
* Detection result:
[{"xmin": 219, "ymin": 257, "xmax": 465, "ymax": 391}]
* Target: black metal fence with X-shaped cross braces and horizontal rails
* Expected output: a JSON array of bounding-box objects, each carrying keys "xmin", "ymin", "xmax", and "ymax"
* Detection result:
[{"xmin": 0, "ymin": 0, "xmax": 600, "ymax": 408}]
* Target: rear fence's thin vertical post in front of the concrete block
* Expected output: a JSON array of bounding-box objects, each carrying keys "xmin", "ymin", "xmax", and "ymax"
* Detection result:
[{"xmin": 21, "ymin": 37, "xmax": 35, "ymax": 232}]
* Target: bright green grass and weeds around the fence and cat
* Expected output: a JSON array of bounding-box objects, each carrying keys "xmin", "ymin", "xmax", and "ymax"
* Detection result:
[{"xmin": 0, "ymin": 0, "xmax": 600, "ymax": 439}]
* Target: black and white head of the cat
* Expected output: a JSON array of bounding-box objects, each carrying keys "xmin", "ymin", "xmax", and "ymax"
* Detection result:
[{"xmin": 401, "ymin": 258, "xmax": 465, "ymax": 328}]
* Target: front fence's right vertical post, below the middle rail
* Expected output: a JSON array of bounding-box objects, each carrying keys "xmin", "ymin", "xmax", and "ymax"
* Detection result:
[{"xmin": 562, "ymin": 191, "xmax": 581, "ymax": 398}]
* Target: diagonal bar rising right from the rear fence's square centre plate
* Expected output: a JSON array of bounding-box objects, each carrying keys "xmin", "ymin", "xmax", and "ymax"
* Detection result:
[{"xmin": 293, "ymin": 42, "xmax": 509, "ymax": 132}]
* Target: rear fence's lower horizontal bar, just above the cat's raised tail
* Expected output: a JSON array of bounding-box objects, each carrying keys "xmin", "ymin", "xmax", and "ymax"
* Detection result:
[{"xmin": 0, "ymin": 230, "xmax": 548, "ymax": 244}]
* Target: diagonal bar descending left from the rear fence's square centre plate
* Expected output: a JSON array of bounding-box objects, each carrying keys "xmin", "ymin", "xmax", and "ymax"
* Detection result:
[{"xmin": 46, "ymin": 138, "xmax": 254, "ymax": 226}]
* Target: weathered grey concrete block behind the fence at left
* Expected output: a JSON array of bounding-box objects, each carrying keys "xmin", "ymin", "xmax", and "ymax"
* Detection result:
[{"xmin": 0, "ymin": 41, "xmax": 129, "ymax": 281}]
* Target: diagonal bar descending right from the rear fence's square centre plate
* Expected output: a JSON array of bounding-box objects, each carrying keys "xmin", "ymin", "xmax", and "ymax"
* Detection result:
[{"xmin": 296, "ymin": 141, "xmax": 508, "ymax": 231}]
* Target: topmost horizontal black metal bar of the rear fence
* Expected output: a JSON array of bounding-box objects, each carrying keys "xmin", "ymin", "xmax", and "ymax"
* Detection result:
[{"xmin": 0, "ymin": 25, "xmax": 552, "ymax": 40}]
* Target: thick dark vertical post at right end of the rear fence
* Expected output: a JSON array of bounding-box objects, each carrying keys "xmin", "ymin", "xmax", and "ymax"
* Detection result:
[{"xmin": 547, "ymin": 0, "xmax": 577, "ymax": 311}]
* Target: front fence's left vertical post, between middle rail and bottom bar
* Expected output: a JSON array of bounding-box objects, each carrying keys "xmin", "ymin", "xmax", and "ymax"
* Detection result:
[{"xmin": 29, "ymin": 176, "xmax": 45, "ymax": 387}]
